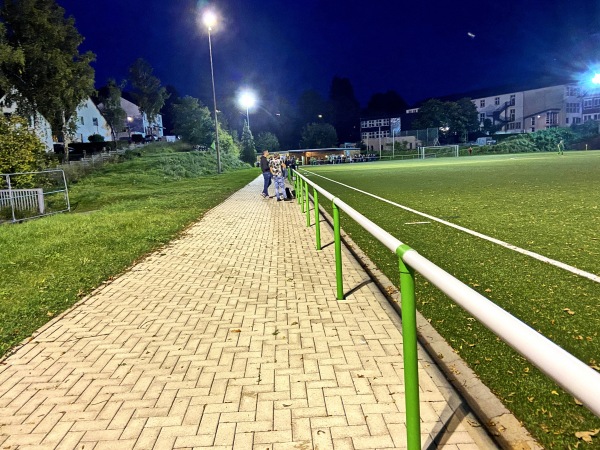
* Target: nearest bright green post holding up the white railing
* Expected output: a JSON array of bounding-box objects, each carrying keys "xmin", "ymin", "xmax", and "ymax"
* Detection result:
[{"xmin": 396, "ymin": 244, "xmax": 421, "ymax": 450}]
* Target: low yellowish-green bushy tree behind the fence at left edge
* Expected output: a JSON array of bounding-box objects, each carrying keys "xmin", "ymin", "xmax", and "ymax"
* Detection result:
[{"xmin": 0, "ymin": 115, "xmax": 47, "ymax": 187}]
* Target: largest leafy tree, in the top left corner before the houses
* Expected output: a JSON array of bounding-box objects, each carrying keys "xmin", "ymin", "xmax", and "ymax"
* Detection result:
[{"xmin": 0, "ymin": 0, "xmax": 95, "ymax": 162}]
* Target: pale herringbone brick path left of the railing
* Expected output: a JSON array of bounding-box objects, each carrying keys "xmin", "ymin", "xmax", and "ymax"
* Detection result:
[{"xmin": 0, "ymin": 177, "xmax": 496, "ymax": 450}]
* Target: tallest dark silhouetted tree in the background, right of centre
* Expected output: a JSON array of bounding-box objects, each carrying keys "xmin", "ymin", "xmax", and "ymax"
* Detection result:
[{"xmin": 329, "ymin": 77, "xmax": 360, "ymax": 142}]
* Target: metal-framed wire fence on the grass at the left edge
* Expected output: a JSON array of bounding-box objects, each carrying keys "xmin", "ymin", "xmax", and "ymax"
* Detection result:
[{"xmin": 0, "ymin": 169, "xmax": 71, "ymax": 223}]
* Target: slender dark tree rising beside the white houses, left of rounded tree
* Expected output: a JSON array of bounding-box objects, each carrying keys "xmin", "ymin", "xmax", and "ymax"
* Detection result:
[{"xmin": 129, "ymin": 58, "xmax": 169, "ymax": 122}]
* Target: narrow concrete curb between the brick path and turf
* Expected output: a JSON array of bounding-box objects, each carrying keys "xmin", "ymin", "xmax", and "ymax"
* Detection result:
[{"xmin": 310, "ymin": 195, "xmax": 543, "ymax": 450}]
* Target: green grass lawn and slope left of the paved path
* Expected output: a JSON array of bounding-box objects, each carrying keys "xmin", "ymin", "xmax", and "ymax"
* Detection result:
[{"xmin": 0, "ymin": 149, "xmax": 259, "ymax": 355}]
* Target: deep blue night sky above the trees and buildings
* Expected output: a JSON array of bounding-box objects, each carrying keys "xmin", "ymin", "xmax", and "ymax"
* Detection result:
[{"xmin": 57, "ymin": 0, "xmax": 600, "ymax": 106}]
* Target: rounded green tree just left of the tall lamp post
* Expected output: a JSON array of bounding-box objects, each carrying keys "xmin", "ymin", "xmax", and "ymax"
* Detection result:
[{"xmin": 172, "ymin": 95, "xmax": 214, "ymax": 147}]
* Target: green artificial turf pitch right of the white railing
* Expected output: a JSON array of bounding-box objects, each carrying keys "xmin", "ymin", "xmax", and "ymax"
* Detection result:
[{"xmin": 302, "ymin": 151, "xmax": 600, "ymax": 449}]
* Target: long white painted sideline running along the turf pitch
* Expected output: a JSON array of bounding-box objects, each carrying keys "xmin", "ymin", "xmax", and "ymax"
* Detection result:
[{"xmin": 304, "ymin": 170, "xmax": 600, "ymax": 283}]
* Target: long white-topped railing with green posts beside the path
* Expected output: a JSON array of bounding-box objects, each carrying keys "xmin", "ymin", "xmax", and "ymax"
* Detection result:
[{"xmin": 293, "ymin": 171, "xmax": 600, "ymax": 450}]
